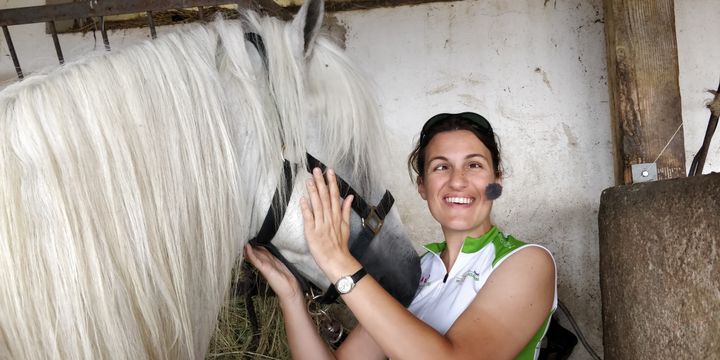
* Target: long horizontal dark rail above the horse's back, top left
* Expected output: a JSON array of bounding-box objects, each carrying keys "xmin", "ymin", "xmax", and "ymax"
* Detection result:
[{"xmin": 0, "ymin": 0, "xmax": 249, "ymax": 26}]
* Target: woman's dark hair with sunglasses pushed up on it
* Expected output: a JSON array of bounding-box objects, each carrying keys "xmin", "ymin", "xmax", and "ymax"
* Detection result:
[{"xmin": 408, "ymin": 112, "xmax": 502, "ymax": 180}]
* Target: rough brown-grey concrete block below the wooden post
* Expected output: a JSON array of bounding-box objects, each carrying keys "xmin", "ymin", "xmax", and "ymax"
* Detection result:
[{"xmin": 599, "ymin": 173, "xmax": 720, "ymax": 359}]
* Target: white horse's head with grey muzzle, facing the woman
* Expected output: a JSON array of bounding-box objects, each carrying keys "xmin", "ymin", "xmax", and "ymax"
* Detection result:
[{"xmin": 219, "ymin": 0, "xmax": 420, "ymax": 305}]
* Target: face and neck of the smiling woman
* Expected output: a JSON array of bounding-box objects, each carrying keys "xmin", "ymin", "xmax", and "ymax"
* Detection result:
[{"xmin": 418, "ymin": 130, "xmax": 502, "ymax": 238}]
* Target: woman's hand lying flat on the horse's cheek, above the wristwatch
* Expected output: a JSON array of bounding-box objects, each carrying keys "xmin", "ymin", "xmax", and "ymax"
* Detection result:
[{"xmin": 300, "ymin": 168, "xmax": 360, "ymax": 282}]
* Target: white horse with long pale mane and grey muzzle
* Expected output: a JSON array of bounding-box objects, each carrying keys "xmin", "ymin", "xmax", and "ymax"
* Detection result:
[{"xmin": 0, "ymin": 0, "xmax": 419, "ymax": 359}]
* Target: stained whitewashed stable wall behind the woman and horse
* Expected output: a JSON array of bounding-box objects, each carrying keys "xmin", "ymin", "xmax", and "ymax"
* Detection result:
[{"xmin": 0, "ymin": 0, "xmax": 720, "ymax": 359}]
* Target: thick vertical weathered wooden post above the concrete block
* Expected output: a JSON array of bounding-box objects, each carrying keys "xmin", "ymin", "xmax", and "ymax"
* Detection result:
[{"xmin": 604, "ymin": 0, "xmax": 686, "ymax": 184}]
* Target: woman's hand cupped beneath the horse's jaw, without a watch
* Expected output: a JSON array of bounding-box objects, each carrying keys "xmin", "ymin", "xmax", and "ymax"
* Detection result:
[{"xmin": 245, "ymin": 244, "xmax": 304, "ymax": 303}]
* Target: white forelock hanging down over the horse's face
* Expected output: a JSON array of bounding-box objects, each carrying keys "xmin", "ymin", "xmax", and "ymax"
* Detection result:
[{"xmin": 220, "ymin": 12, "xmax": 387, "ymax": 202}]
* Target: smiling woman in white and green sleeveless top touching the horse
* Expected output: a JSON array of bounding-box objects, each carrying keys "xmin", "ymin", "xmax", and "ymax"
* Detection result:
[{"xmin": 246, "ymin": 113, "xmax": 557, "ymax": 359}]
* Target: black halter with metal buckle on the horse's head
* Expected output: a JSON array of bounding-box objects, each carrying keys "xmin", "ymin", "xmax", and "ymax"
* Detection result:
[{"xmin": 250, "ymin": 154, "xmax": 395, "ymax": 304}]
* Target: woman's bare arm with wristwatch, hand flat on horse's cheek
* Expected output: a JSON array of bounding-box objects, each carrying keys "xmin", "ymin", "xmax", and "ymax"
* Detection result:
[{"xmin": 301, "ymin": 169, "xmax": 555, "ymax": 360}]
